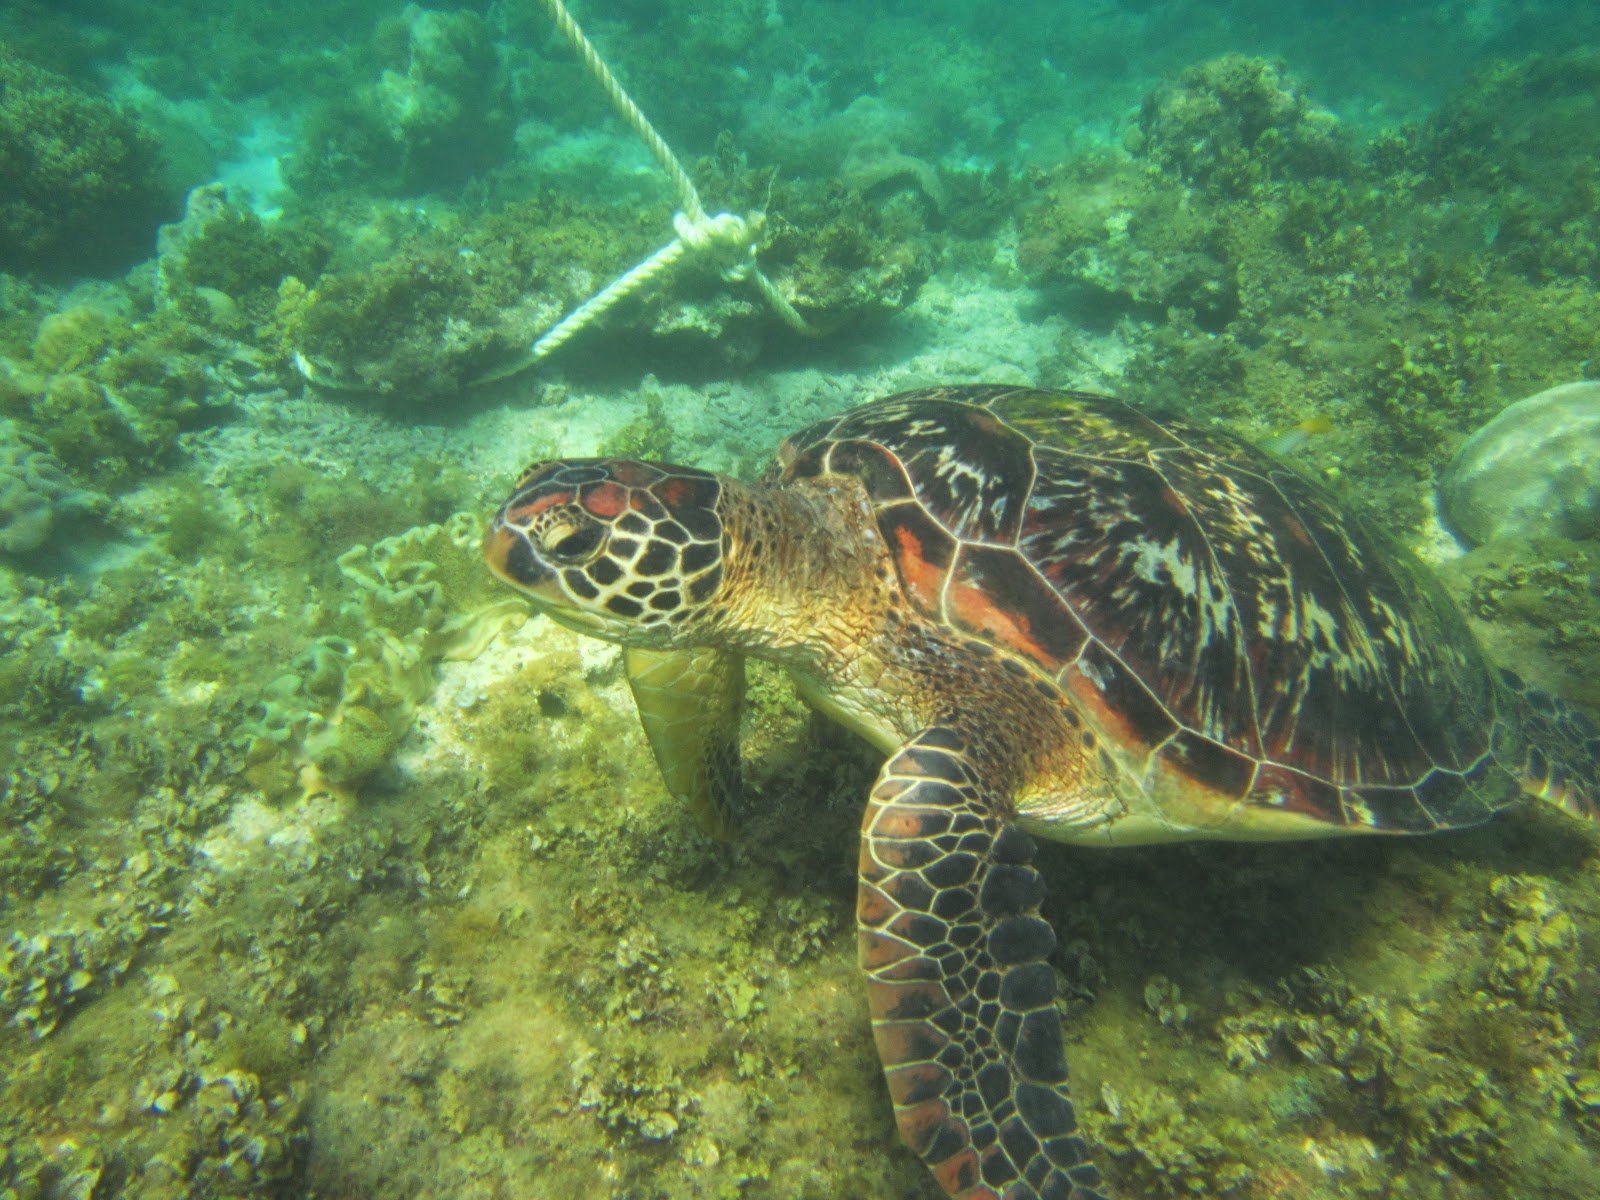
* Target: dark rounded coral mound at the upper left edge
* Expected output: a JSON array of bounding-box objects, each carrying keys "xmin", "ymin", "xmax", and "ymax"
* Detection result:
[{"xmin": 0, "ymin": 46, "xmax": 170, "ymax": 274}]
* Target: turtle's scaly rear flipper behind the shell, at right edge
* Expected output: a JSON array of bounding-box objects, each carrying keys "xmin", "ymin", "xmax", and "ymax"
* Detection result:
[{"xmin": 1494, "ymin": 670, "xmax": 1600, "ymax": 821}]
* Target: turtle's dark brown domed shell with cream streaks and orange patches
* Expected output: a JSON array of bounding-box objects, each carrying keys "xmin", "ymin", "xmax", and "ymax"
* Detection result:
[{"xmin": 773, "ymin": 387, "xmax": 1517, "ymax": 832}]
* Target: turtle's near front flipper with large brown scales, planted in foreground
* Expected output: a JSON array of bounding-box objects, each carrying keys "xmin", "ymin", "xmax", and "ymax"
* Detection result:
[{"xmin": 856, "ymin": 728, "xmax": 1102, "ymax": 1200}]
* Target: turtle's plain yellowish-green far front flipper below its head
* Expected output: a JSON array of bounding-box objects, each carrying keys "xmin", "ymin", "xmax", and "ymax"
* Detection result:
[{"xmin": 622, "ymin": 646, "xmax": 744, "ymax": 837}]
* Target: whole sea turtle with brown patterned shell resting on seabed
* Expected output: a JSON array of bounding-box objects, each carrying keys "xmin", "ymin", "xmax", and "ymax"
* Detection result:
[{"xmin": 485, "ymin": 386, "xmax": 1600, "ymax": 1200}]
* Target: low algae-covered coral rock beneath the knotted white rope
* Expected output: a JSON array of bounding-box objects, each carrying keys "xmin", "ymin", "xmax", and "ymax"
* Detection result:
[{"xmin": 277, "ymin": 147, "xmax": 930, "ymax": 406}]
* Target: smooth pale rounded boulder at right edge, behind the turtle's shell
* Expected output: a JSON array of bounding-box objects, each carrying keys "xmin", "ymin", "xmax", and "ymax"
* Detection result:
[{"xmin": 1438, "ymin": 382, "xmax": 1600, "ymax": 544}]
